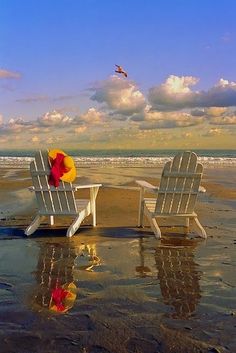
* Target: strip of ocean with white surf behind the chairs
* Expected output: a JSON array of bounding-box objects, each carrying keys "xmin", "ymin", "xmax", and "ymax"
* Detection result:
[{"xmin": 0, "ymin": 149, "xmax": 236, "ymax": 168}]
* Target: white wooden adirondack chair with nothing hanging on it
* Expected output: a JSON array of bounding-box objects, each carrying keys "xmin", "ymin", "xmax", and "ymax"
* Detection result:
[{"xmin": 136, "ymin": 151, "xmax": 207, "ymax": 239}]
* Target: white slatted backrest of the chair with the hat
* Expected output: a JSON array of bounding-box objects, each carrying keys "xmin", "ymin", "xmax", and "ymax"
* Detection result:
[{"xmin": 30, "ymin": 151, "xmax": 77, "ymax": 215}]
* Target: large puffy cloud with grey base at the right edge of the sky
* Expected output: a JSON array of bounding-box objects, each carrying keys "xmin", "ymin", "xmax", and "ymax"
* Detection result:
[{"xmin": 148, "ymin": 75, "xmax": 236, "ymax": 110}]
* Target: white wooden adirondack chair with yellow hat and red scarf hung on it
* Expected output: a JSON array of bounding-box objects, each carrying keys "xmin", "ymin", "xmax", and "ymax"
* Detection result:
[{"xmin": 25, "ymin": 151, "xmax": 101, "ymax": 237}]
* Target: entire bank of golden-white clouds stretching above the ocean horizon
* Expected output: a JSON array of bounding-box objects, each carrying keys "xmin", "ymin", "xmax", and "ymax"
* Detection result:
[{"xmin": 0, "ymin": 75, "xmax": 236, "ymax": 146}]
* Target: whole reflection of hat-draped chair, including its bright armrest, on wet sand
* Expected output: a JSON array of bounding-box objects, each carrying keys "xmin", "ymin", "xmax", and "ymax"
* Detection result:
[{"xmin": 34, "ymin": 241, "xmax": 100, "ymax": 313}]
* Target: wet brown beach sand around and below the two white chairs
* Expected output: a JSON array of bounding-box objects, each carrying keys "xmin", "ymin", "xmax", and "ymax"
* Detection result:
[{"xmin": 0, "ymin": 167, "xmax": 236, "ymax": 353}]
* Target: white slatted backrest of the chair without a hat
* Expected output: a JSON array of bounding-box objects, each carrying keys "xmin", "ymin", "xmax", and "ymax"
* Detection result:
[{"xmin": 155, "ymin": 151, "xmax": 203, "ymax": 214}]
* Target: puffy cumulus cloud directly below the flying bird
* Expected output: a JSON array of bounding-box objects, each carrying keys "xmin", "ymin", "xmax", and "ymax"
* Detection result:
[{"xmin": 91, "ymin": 76, "xmax": 146, "ymax": 118}]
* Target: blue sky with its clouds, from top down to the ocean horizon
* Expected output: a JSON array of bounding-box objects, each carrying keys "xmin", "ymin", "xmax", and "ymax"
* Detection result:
[{"xmin": 0, "ymin": 0, "xmax": 236, "ymax": 148}]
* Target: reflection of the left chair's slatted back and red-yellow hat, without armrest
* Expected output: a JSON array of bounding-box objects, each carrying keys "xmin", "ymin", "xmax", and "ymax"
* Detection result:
[{"xmin": 31, "ymin": 243, "xmax": 77, "ymax": 313}]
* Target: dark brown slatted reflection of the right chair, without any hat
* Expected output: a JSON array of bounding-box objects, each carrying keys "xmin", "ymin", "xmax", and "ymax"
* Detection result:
[{"xmin": 155, "ymin": 239, "xmax": 201, "ymax": 319}]
